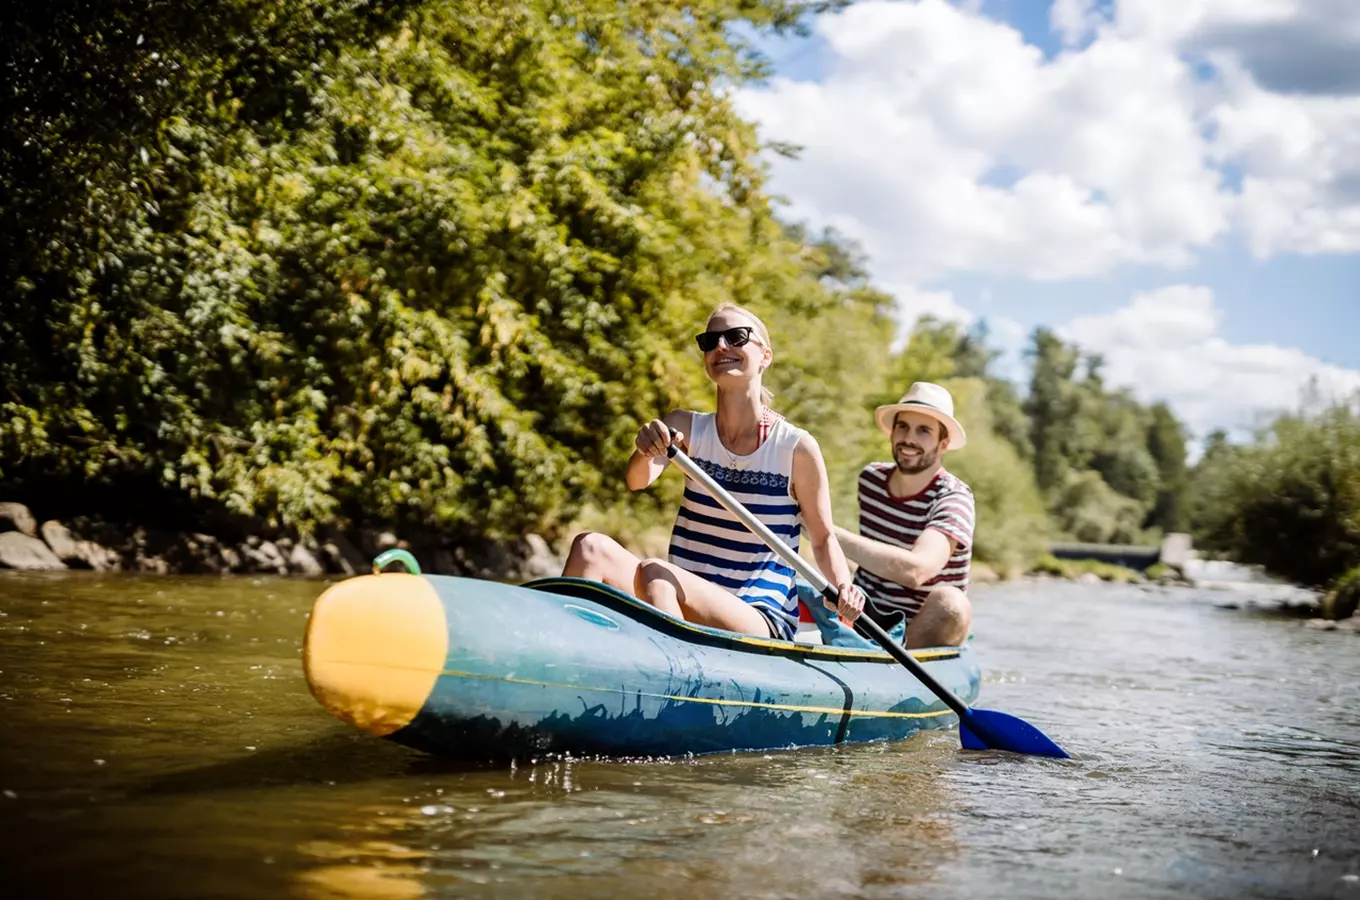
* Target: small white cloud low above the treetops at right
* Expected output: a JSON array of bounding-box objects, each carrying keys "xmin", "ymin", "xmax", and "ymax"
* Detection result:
[{"xmin": 1057, "ymin": 284, "xmax": 1360, "ymax": 438}]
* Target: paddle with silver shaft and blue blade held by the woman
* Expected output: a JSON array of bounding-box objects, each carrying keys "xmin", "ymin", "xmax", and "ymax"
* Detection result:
[{"xmin": 666, "ymin": 432, "xmax": 1070, "ymax": 759}]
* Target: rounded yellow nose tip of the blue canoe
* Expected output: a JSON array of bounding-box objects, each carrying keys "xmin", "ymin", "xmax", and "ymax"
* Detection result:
[{"xmin": 302, "ymin": 574, "xmax": 449, "ymax": 735}]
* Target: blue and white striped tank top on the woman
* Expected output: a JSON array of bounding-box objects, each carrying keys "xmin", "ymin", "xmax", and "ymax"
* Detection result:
[{"xmin": 669, "ymin": 412, "xmax": 806, "ymax": 640}]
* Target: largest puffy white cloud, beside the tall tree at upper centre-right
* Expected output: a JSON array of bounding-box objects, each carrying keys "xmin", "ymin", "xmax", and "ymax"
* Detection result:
[{"xmin": 738, "ymin": 0, "xmax": 1228, "ymax": 281}]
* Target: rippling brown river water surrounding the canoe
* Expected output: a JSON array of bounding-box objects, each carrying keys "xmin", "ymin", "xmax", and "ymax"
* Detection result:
[{"xmin": 0, "ymin": 572, "xmax": 1360, "ymax": 900}]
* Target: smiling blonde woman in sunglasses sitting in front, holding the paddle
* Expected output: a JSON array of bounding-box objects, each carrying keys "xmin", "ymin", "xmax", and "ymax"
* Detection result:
[{"xmin": 563, "ymin": 305, "xmax": 864, "ymax": 640}]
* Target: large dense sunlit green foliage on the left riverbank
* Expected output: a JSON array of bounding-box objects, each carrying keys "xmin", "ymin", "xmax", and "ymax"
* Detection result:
[{"xmin": 0, "ymin": 0, "xmax": 848, "ymax": 543}]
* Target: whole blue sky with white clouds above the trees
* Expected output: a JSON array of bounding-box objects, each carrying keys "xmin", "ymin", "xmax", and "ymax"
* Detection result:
[{"xmin": 736, "ymin": 0, "xmax": 1360, "ymax": 439}]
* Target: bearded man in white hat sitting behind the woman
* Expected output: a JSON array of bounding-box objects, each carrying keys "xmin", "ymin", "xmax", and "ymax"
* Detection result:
[{"xmin": 835, "ymin": 382, "xmax": 974, "ymax": 650}]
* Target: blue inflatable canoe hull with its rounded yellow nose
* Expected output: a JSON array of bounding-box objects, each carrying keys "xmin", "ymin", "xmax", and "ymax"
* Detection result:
[{"xmin": 303, "ymin": 575, "xmax": 981, "ymax": 759}]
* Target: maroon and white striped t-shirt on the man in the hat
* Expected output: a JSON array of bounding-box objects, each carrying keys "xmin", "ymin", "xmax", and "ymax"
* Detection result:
[{"xmin": 854, "ymin": 462, "xmax": 974, "ymax": 625}]
